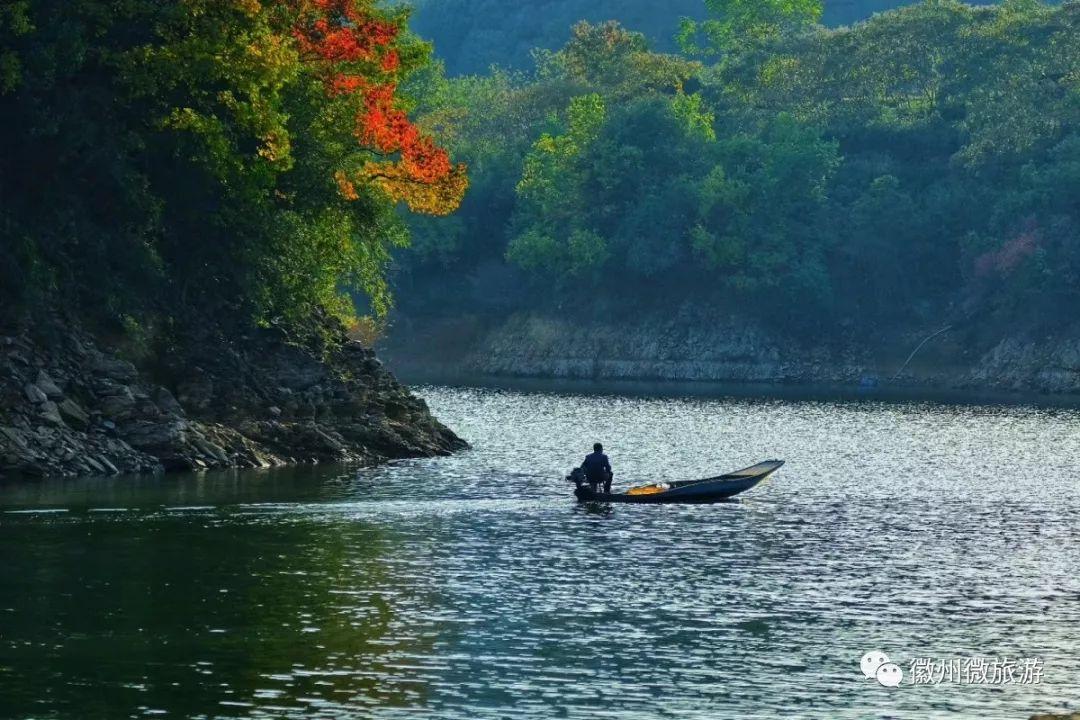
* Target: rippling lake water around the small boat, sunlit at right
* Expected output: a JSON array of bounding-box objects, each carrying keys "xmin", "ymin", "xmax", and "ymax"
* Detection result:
[{"xmin": 0, "ymin": 389, "xmax": 1080, "ymax": 719}]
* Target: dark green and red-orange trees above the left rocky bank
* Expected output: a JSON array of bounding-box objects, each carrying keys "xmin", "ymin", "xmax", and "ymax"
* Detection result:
[{"xmin": 0, "ymin": 0, "xmax": 468, "ymax": 332}]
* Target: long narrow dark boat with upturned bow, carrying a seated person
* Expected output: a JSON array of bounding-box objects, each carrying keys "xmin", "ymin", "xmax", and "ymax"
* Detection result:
[{"xmin": 571, "ymin": 460, "xmax": 784, "ymax": 504}]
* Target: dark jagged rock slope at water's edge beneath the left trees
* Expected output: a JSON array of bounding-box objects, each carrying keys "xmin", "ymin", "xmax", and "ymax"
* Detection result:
[{"xmin": 0, "ymin": 316, "xmax": 467, "ymax": 478}]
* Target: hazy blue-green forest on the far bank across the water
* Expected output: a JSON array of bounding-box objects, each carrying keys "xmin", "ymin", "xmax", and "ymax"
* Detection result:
[{"xmin": 396, "ymin": 0, "xmax": 1080, "ymax": 332}]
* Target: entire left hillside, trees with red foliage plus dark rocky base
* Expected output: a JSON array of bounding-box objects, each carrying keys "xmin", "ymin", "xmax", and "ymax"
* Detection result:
[{"xmin": 0, "ymin": 0, "xmax": 468, "ymax": 478}]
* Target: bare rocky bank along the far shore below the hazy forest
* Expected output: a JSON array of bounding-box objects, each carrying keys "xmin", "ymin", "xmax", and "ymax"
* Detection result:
[{"xmin": 384, "ymin": 305, "xmax": 1080, "ymax": 394}]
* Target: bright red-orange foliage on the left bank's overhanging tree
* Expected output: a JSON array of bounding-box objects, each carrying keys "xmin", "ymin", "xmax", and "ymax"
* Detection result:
[{"xmin": 293, "ymin": 0, "xmax": 469, "ymax": 215}]
